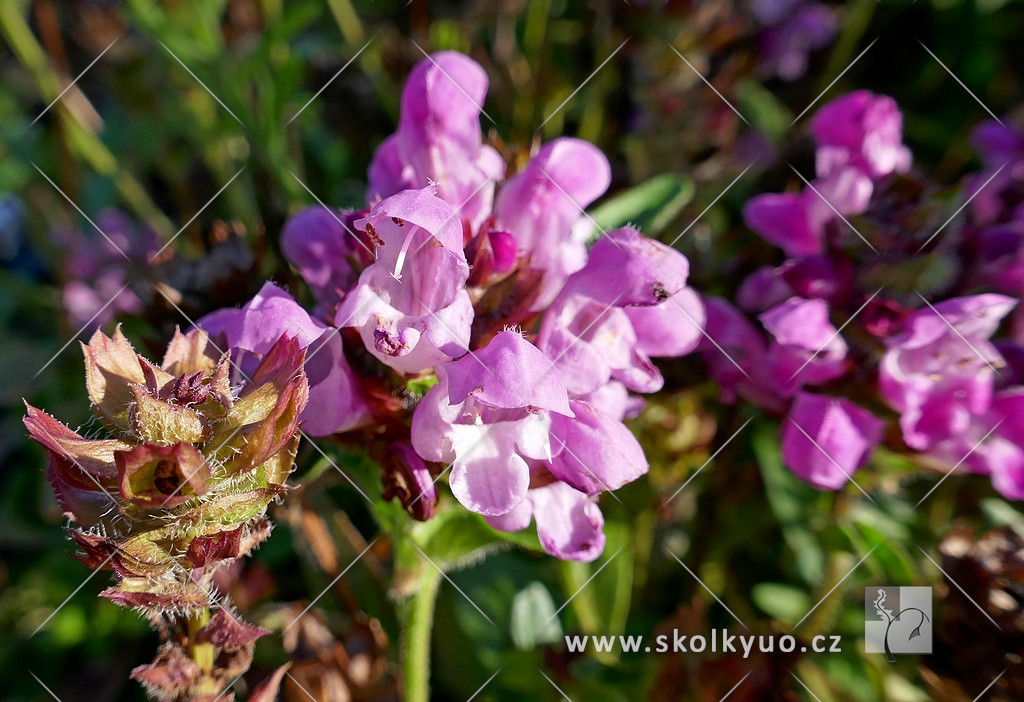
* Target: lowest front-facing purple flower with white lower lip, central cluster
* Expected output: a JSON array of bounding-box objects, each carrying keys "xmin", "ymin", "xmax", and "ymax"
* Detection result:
[{"xmin": 412, "ymin": 331, "xmax": 572, "ymax": 516}]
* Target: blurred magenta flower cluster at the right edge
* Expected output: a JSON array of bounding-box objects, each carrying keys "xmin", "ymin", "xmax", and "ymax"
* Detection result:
[{"xmin": 702, "ymin": 91, "xmax": 1024, "ymax": 498}]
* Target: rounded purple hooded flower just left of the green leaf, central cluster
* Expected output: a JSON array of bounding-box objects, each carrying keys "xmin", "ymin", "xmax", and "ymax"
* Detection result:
[{"xmin": 495, "ymin": 137, "xmax": 611, "ymax": 310}]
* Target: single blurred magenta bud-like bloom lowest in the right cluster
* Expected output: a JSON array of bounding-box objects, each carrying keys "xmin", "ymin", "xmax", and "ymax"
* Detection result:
[{"xmin": 782, "ymin": 392, "xmax": 884, "ymax": 490}]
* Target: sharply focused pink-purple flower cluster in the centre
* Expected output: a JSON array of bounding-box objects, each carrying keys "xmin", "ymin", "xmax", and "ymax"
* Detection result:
[{"xmin": 199, "ymin": 52, "xmax": 705, "ymax": 560}]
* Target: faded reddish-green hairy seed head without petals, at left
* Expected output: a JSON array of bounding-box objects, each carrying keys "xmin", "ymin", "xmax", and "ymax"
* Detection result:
[{"xmin": 25, "ymin": 327, "xmax": 308, "ymax": 699}]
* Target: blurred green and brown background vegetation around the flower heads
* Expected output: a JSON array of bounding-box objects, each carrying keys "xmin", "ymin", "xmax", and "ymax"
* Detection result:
[{"xmin": 0, "ymin": 0, "xmax": 1024, "ymax": 702}]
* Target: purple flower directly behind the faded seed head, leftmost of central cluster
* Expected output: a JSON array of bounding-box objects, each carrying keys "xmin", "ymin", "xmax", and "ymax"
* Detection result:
[{"xmin": 198, "ymin": 282, "xmax": 370, "ymax": 436}]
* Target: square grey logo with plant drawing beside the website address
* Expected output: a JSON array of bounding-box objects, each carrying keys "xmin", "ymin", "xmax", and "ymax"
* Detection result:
[{"xmin": 864, "ymin": 587, "xmax": 932, "ymax": 663}]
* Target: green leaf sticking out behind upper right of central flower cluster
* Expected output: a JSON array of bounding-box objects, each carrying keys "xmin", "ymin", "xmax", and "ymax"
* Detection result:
[{"xmin": 590, "ymin": 173, "xmax": 693, "ymax": 240}]
